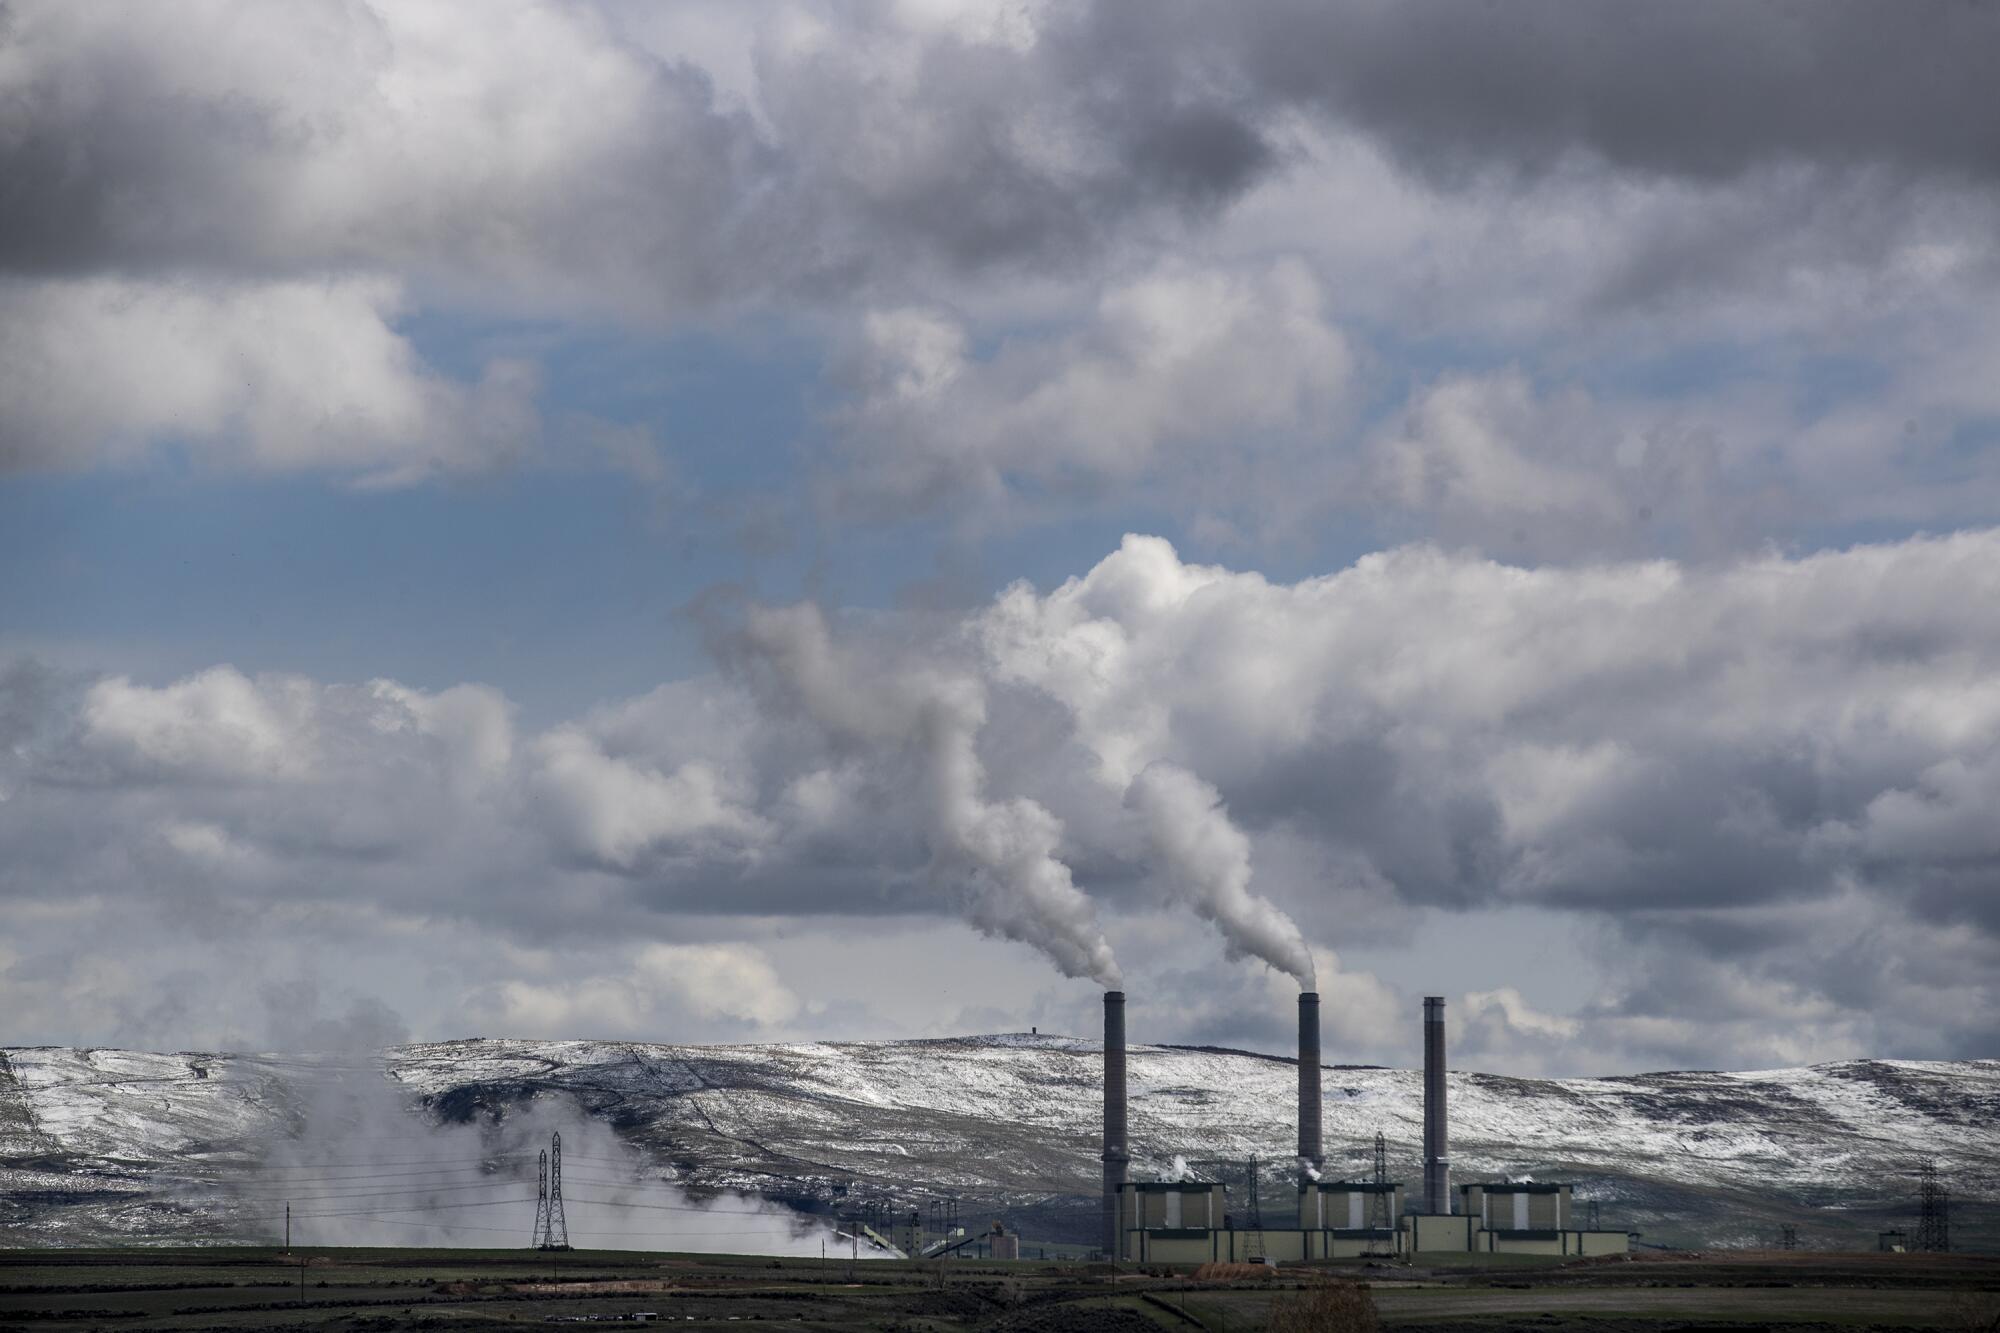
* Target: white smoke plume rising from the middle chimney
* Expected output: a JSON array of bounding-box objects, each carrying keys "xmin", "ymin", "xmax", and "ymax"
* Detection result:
[{"xmin": 1126, "ymin": 761, "xmax": 1318, "ymax": 991}]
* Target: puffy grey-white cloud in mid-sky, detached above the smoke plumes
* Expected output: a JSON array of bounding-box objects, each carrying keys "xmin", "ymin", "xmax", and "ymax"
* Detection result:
[{"xmin": 820, "ymin": 262, "xmax": 1352, "ymax": 504}]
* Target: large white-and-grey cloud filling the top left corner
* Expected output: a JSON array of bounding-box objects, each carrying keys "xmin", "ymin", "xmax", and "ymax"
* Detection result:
[{"xmin": 0, "ymin": 4, "xmax": 782, "ymax": 300}]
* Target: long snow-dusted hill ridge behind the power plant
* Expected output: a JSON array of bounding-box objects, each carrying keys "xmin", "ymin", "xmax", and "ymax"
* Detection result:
[{"xmin": 0, "ymin": 1035, "xmax": 2000, "ymax": 1245}]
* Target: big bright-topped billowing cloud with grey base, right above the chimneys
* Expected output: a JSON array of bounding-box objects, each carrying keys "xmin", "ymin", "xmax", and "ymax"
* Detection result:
[{"xmin": 986, "ymin": 534, "xmax": 1994, "ymax": 1039}]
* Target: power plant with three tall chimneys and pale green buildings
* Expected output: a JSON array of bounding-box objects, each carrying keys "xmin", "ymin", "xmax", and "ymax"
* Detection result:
[{"xmin": 1104, "ymin": 991, "xmax": 1630, "ymax": 1263}]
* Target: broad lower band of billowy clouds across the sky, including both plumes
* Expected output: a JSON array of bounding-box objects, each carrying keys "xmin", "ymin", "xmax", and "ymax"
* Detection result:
[{"xmin": 0, "ymin": 530, "xmax": 2000, "ymax": 1069}]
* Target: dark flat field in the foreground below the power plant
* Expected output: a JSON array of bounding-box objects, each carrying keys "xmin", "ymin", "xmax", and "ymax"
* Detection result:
[{"xmin": 0, "ymin": 1249, "xmax": 2000, "ymax": 1333}]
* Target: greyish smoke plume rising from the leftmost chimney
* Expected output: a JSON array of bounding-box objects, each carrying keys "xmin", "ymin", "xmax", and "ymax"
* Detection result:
[{"xmin": 742, "ymin": 604, "xmax": 1124, "ymax": 989}]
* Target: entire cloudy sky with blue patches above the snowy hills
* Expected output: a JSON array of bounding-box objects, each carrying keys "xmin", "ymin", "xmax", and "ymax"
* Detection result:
[{"xmin": 0, "ymin": 0, "xmax": 2000, "ymax": 1073}]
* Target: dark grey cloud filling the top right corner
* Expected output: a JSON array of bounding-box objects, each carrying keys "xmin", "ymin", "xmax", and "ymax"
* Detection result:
[{"xmin": 1192, "ymin": 0, "xmax": 2000, "ymax": 182}]
